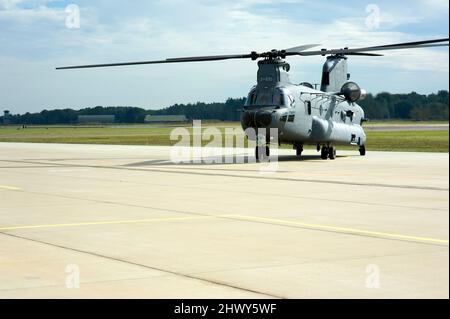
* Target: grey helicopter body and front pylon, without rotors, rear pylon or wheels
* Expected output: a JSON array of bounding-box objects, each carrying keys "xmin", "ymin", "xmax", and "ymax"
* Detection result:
[{"xmin": 241, "ymin": 60, "xmax": 366, "ymax": 156}]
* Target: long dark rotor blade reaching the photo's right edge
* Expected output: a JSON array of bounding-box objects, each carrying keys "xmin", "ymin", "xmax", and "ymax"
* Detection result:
[{"xmin": 298, "ymin": 38, "xmax": 449, "ymax": 56}]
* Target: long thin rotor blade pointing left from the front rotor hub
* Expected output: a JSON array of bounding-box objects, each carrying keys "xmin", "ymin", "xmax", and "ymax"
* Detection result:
[{"xmin": 56, "ymin": 54, "xmax": 252, "ymax": 70}]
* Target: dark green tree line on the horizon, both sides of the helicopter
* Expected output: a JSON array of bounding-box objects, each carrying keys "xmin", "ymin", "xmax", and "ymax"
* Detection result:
[{"xmin": 0, "ymin": 91, "xmax": 449, "ymax": 125}]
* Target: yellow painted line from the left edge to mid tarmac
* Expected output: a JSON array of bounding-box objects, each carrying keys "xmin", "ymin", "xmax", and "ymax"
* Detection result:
[{"xmin": 0, "ymin": 216, "xmax": 215, "ymax": 231}]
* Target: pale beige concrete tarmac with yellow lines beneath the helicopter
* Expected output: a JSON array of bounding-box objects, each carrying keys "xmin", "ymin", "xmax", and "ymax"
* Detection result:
[{"xmin": 0, "ymin": 143, "xmax": 449, "ymax": 298}]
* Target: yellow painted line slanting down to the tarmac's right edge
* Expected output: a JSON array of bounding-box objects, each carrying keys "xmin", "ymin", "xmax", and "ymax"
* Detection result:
[{"xmin": 228, "ymin": 215, "xmax": 449, "ymax": 245}]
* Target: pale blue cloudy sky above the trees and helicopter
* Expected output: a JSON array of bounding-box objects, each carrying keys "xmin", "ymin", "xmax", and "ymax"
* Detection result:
[{"xmin": 0, "ymin": 0, "xmax": 449, "ymax": 113}]
